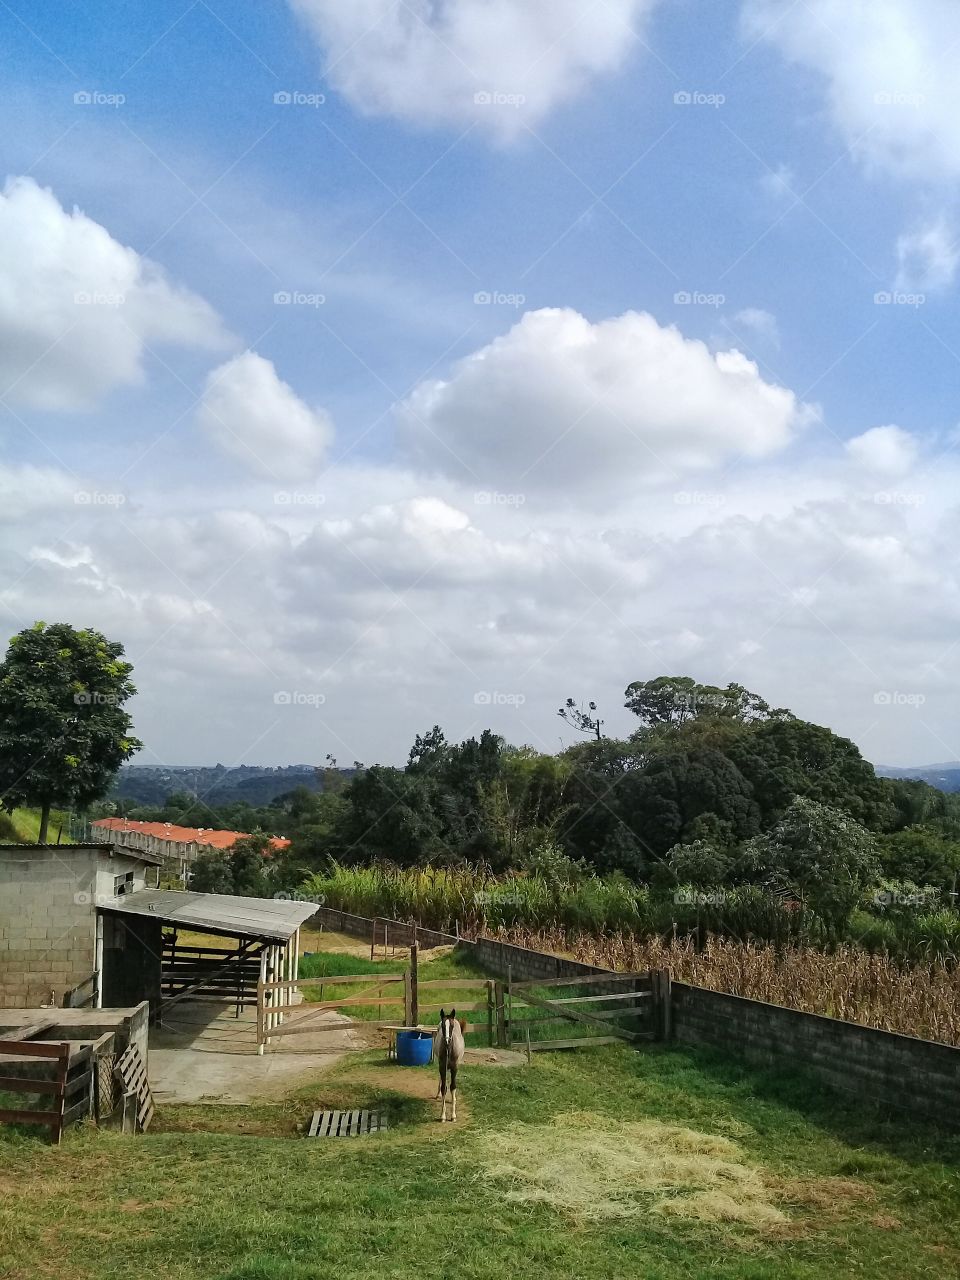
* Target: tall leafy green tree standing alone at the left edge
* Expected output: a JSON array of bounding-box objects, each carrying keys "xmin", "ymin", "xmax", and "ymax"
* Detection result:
[{"xmin": 0, "ymin": 622, "xmax": 142, "ymax": 845}]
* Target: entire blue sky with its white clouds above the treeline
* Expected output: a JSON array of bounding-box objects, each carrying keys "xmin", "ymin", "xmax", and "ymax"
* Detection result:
[{"xmin": 0, "ymin": 0, "xmax": 960, "ymax": 763}]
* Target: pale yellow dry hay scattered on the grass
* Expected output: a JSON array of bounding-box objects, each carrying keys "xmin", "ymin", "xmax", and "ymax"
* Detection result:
[{"xmin": 465, "ymin": 1111, "xmax": 786, "ymax": 1228}]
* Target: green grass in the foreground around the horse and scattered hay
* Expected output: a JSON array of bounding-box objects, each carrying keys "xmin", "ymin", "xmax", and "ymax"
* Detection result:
[{"xmin": 0, "ymin": 1029, "xmax": 960, "ymax": 1280}]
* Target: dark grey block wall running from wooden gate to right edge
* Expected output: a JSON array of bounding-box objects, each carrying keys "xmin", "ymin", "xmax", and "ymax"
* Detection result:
[{"xmin": 672, "ymin": 982, "xmax": 960, "ymax": 1128}]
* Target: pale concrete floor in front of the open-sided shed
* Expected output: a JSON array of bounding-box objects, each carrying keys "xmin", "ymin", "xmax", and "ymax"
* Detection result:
[{"xmin": 150, "ymin": 1002, "xmax": 369, "ymax": 1105}]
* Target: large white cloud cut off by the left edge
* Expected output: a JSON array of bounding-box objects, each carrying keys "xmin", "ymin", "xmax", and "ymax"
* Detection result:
[{"xmin": 0, "ymin": 178, "xmax": 228, "ymax": 410}]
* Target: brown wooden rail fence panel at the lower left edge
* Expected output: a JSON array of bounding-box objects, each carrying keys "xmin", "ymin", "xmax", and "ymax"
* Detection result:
[{"xmin": 0, "ymin": 1037, "xmax": 98, "ymax": 1144}]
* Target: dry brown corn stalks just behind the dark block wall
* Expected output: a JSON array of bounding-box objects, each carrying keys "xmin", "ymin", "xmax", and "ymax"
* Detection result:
[{"xmin": 497, "ymin": 929, "xmax": 960, "ymax": 1047}]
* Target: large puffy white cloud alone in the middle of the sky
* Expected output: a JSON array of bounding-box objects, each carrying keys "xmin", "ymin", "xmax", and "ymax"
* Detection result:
[{"xmin": 398, "ymin": 310, "xmax": 813, "ymax": 504}]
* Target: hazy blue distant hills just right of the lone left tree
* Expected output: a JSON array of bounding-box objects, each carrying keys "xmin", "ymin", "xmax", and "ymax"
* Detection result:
[{"xmin": 110, "ymin": 764, "xmax": 325, "ymax": 806}]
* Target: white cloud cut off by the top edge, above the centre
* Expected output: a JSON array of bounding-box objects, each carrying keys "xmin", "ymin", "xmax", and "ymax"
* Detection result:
[{"xmin": 291, "ymin": 0, "xmax": 655, "ymax": 138}]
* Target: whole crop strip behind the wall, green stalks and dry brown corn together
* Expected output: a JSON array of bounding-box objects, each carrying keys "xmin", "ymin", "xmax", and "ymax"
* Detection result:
[{"xmin": 305, "ymin": 865, "xmax": 960, "ymax": 1046}]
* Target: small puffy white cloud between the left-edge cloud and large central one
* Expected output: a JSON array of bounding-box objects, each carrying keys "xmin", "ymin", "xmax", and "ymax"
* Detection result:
[{"xmin": 197, "ymin": 351, "xmax": 333, "ymax": 480}]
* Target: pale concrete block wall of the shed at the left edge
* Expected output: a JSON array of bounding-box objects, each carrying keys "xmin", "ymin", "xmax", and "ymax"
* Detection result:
[{"xmin": 0, "ymin": 845, "xmax": 97, "ymax": 1009}]
